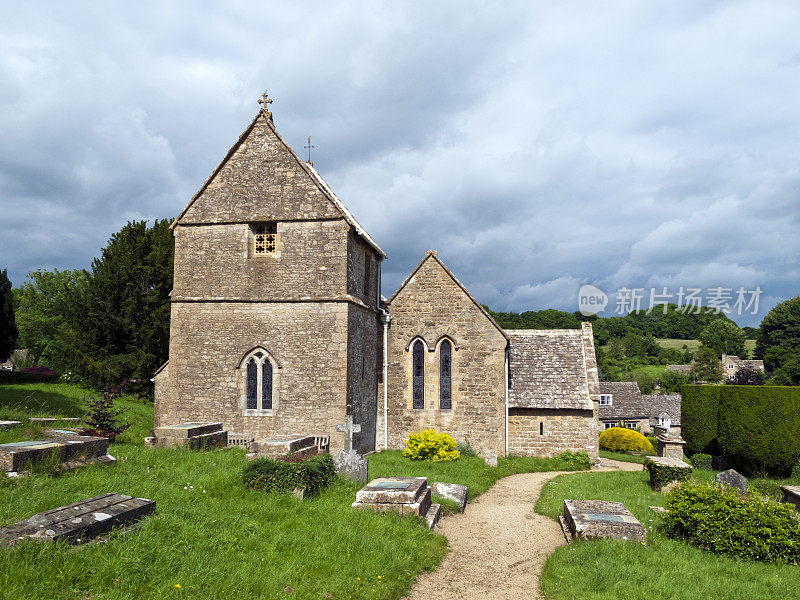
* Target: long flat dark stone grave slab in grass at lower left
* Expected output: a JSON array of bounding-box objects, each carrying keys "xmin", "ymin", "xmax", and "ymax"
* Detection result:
[{"xmin": 0, "ymin": 493, "xmax": 156, "ymax": 546}]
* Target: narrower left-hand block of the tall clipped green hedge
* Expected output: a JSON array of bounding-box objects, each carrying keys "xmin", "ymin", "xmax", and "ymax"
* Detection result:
[{"xmin": 681, "ymin": 385, "xmax": 723, "ymax": 455}]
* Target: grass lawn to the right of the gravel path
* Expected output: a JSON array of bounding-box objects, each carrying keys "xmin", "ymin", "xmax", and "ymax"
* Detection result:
[{"xmin": 536, "ymin": 471, "xmax": 800, "ymax": 600}]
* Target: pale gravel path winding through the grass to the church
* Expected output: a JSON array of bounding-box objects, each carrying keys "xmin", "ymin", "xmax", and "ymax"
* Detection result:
[{"xmin": 408, "ymin": 459, "xmax": 642, "ymax": 600}]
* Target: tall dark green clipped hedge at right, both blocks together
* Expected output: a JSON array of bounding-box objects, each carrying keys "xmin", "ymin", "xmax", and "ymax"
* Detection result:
[{"xmin": 681, "ymin": 385, "xmax": 800, "ymax": 475}]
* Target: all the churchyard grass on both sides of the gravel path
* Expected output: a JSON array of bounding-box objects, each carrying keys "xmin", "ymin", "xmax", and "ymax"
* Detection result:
[{"xmin": 0, "ymin": 384, "xmax": 800, "ymax": 600}]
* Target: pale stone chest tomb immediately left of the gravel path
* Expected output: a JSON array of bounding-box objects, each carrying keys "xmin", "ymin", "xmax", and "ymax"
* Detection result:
[{"xmin": 353, "ymin": 477, "xmax": 441, "ymax": 529}]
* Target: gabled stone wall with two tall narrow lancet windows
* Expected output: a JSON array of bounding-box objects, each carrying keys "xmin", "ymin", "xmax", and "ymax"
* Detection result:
[{"xmin": 378, "ymin": 253, "xmax": 506, "ymax": 456}]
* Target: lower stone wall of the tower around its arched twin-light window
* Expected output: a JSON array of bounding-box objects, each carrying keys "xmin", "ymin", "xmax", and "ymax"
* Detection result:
[{"xmin": 155, "ymin": 302, "xmax": 350, "ymax": 451}]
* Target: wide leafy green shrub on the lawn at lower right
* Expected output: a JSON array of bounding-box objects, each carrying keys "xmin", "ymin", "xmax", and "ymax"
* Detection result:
[{"xmin": 663, "ymin": 482, "xmax": 800, "ymax": 564}]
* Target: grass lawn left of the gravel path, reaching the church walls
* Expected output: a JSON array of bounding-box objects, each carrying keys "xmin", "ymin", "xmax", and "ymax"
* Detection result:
[{"xmin": 0, "ymin": 384, "xmax": 588, "ymax": 600}]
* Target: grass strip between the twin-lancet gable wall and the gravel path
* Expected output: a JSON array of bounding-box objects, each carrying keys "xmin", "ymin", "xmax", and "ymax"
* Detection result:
[{"xmin": 369, "ymin": 450, "xmax": 580, "ymax": 500}]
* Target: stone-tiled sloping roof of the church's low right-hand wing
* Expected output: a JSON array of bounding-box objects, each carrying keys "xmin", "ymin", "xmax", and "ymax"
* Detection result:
[{"xmin": 506, "ymin": 329, "xmax": 594, "ymax": 410}]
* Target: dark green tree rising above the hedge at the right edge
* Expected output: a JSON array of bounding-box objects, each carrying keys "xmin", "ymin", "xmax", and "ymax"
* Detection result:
[{"xmin": 755, "ymin": 296, "xmax": 800, "ymax": 385}]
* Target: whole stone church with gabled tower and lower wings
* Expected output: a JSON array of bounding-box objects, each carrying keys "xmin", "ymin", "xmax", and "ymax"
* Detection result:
[{"xmin": 154, "ymin": 101, "xmax": 599, "ymax": 457}]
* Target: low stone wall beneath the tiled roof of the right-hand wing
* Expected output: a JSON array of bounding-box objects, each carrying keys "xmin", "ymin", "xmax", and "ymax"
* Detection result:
[{"xmin": 508, "ymin": 408, "xmax": 598, "ymax": 458}]
